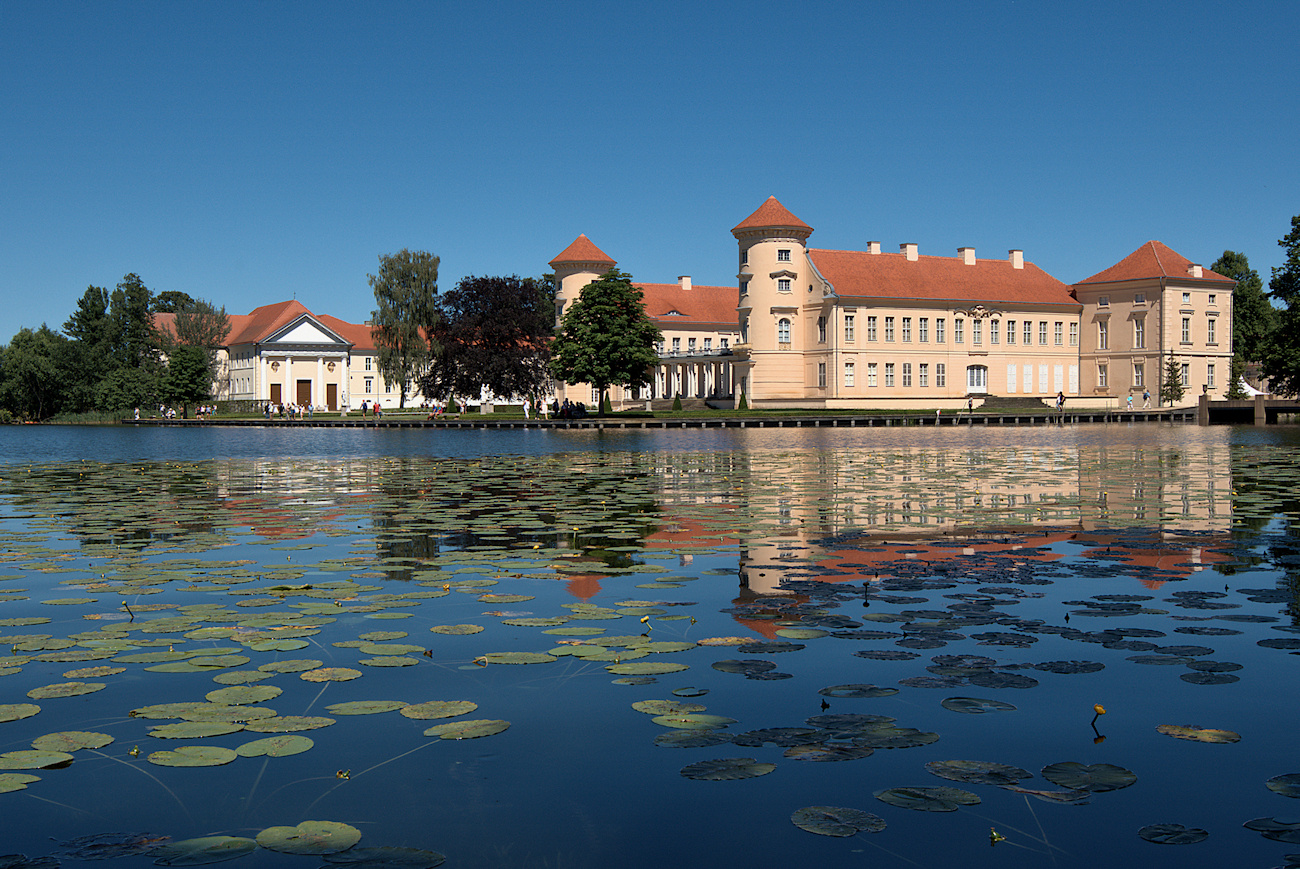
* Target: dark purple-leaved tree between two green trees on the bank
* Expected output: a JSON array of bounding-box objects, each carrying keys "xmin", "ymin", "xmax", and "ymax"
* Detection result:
[{"xmin": 420, "ymin": 274, "xmax": 555, "ymax": 398}]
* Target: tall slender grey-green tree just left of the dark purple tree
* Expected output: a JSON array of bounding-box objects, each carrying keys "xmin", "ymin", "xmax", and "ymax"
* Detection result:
[{"xmin": 367, "ymin": 247, "xmax": 438, "ymax": 407}]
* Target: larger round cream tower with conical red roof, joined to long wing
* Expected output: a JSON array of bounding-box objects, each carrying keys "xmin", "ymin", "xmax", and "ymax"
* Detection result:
[{"xmin": 732, "ymin": 196, "xmax": 813, "ymax": 401}]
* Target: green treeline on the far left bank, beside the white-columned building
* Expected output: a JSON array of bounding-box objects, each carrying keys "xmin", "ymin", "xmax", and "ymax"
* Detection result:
[{"xmin": 0, "ymin": 273, "xmax": 230, "ymax": 421}]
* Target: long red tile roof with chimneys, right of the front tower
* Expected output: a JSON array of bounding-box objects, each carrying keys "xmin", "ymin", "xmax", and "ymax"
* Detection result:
[{"xmin": 809, "ymin": 250, "xmax": 1079, "ymax": 308}]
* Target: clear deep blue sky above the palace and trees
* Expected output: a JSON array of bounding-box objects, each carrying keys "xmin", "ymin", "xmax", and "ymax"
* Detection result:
[{"xmin": 0, "ymin": 0, "xmax": 1300, "ymax": 342}]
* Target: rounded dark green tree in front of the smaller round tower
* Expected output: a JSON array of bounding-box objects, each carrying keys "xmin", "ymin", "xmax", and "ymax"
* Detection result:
[{"xmin": 551, "ymin": 268, "xmax": 660, "ymax": 413}]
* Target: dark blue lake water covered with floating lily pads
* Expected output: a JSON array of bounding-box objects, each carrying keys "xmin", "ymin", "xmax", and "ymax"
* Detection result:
[{"xmin": 0, "ymin": 424, "xmax": 1300, "ymax": 869}]
